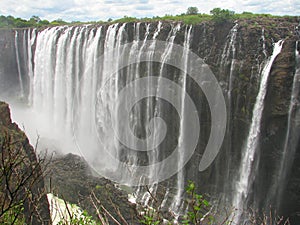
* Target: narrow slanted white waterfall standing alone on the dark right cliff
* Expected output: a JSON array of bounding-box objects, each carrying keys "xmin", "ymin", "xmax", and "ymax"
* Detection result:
[{"xmin": 232, "ymin": 41, "xmax": 283, "ymax": 224}]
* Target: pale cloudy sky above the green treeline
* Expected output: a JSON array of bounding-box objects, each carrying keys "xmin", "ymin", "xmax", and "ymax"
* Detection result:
[{"xmin": 0, "ymin": 0, "xmax": 300, "ymax": 22}]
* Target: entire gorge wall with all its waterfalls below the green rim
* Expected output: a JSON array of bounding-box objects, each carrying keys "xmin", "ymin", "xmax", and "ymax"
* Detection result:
[{"xmin": 0, "ymin": 17, "xmax": 300, "ymax": 224}]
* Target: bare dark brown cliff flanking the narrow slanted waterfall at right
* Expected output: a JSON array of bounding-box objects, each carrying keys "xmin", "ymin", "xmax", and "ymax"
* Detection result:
[{"xmin": 154, "ymin": 18, "xmax": 300, "ymax": 223}]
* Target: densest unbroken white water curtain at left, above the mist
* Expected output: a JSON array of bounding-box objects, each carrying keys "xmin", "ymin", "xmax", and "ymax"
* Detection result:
[{"xmin": 28, "ymin": 26, "xmax": 105, "ymax": 154}]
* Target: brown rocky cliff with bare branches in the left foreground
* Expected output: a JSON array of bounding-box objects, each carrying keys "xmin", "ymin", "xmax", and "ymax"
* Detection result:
[{"xmin": 0, "ymin": 102, "xmax": 51, "ymax": 225}]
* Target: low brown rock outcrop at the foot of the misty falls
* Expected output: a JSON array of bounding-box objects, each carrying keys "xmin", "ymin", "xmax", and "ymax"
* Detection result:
[{"xmin": 46, "ymin": 154, "xmax": 139, "ymax": 224}]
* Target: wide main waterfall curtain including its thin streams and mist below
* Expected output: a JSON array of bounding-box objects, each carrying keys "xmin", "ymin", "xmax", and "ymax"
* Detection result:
[{"xmin": 7, "ymin": 22, "xmax": 218, "ymax": 219}]
